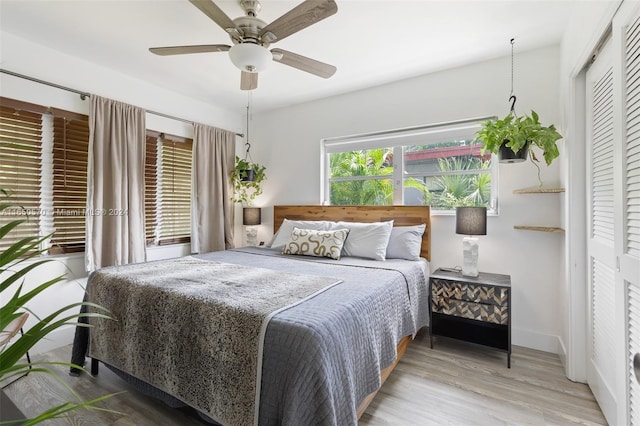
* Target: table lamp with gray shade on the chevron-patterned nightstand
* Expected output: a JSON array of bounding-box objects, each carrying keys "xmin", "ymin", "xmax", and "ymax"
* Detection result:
[{"xmin": 456, "ymin": 207, "xmax": 487, "ymax": 277}]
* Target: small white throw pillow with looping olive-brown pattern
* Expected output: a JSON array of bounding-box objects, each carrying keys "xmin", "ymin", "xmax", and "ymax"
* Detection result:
[{"xmin": 282, "ymin": 228, "xmax": 349, "ymax": 260}]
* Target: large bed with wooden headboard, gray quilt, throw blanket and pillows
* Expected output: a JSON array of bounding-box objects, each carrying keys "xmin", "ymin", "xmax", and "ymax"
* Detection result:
[{"xmin": 72, "ymin": 206, "xmax": 430, "ymax": 425}]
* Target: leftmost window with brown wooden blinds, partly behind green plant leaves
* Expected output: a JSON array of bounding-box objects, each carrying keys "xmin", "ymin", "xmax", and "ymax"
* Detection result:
[{"xmin": 0, "ymin": 98, "xmax": 89, "ymax": 253}]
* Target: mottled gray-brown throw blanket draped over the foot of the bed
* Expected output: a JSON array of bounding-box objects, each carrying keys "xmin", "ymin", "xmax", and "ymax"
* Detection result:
[{"xmin": 88, "ymin": 256, "xmax": 339, "ymax": 425}]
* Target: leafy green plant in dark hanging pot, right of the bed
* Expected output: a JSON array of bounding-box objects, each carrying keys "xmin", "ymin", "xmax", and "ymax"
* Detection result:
[{"xmin": 476, "ymin": 110, "xmax": 562, "ymax": 177}]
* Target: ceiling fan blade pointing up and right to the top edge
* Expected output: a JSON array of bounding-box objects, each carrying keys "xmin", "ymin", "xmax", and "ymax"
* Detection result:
[{"xmin": 260, "ymin": 0, "xmax": 338, "ymax": 43}]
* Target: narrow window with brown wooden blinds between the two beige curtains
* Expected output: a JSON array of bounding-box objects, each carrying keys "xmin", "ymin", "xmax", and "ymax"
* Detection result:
[{"xmin": 145, "ymin": 131, "xmax": 192, "ymax": 245}]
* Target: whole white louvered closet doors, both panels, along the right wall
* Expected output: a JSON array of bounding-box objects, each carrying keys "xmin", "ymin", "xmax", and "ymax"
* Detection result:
[{"xmin": 586, "ymin": 1, "xmax": 640, "ymax": 426}]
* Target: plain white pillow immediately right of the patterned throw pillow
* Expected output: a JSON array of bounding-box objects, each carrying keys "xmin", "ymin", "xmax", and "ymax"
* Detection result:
[{"xmin": 334, "ymin": 220, "xmax": 393, "ymax": 260}]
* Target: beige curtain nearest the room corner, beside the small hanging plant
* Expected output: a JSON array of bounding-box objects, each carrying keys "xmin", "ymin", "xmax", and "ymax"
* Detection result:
[{"xmin": 191, "ymin": 124, "xmax": 236, "ymax": 253}]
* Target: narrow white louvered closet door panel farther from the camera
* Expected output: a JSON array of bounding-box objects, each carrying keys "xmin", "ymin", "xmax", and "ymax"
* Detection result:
[{"xmin": 587, "ymin": 35, "xmax": 619, "ymax": 424}]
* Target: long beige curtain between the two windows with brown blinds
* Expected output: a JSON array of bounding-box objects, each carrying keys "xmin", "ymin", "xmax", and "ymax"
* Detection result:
[{"xmin": 85, "ymin": 95, "xmax": 146, "ymax": 271}]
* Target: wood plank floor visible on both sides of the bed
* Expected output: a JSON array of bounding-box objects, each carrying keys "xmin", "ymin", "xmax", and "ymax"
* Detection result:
[{"xmin": 5, "ymin": 330, "xmax": 606, "ymax": 426}]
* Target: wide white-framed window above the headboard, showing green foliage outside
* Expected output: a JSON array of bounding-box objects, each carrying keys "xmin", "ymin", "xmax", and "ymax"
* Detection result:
[{"xmin": 322, "ymin": 120, "xmax": 497, "ymax": 211}]
